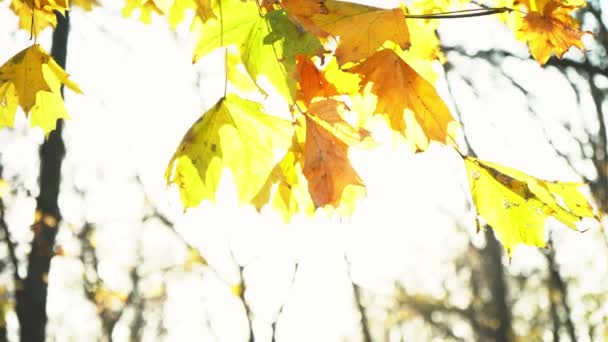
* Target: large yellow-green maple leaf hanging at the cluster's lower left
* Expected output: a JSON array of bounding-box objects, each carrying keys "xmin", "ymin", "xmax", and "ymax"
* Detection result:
[{"xmin": 165, "ymin": 95, "xmax": 293, "ymax": 208}]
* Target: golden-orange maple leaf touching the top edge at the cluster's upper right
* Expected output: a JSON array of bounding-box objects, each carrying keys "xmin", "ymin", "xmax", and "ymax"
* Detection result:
[{"xmin": 306, "ymin": 0, "xmax": 410, "ymax": 65}]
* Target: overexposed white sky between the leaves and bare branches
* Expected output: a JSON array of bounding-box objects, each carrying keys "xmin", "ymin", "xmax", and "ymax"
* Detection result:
[{"xmin": 0, "ymin": 2, "xmax": 605, "ymax": 341}]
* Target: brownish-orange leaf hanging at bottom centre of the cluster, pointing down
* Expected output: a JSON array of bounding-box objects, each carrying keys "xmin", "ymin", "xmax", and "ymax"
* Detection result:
[{"xmin": 302, "ymin": 99, "xmax": 365, "ymax": 207}]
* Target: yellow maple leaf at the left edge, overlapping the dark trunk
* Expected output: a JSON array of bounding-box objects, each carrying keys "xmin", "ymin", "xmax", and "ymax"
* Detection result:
[{"xmin": 0, "ymin": 44, "xmax": 81, "ymax": 135}]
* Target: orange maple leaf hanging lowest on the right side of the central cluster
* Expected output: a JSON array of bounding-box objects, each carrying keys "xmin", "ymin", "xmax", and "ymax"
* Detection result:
[{"xmin": 349, "ymin": 49, "xmax": 456, "ymax": 151}]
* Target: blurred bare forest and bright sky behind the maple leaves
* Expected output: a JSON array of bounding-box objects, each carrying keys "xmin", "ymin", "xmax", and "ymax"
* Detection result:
[{"xmin": 0, "ymin": 0, "xmax": 608, "ymax": 342}]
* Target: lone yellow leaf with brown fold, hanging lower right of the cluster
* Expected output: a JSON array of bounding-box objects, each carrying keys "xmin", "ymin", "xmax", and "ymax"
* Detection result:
[{"xmin": 464, "ymin": 157, "xmax": 598, "ymax": 256}]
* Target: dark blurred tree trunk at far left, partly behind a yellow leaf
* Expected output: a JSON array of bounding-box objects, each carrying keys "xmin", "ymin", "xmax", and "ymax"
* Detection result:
[{"xmin": 16, "ymin": 12, "xmax": 69, "ymax": 342}]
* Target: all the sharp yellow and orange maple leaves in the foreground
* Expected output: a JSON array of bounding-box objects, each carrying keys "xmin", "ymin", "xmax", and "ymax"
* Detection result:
[{"xmin": 0, "ymin": 0, "xmax": 595, "ymax": 254}]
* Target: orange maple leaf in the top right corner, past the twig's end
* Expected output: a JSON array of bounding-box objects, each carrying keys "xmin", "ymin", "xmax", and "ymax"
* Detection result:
[{"xmin": 521, "ymin": 0, "xmax": 587, "ymax": 65}]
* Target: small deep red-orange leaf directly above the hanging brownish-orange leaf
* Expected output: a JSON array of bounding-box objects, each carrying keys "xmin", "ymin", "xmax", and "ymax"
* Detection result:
[{"xmin": 296, "ymin": 55, "xmax": 338, "ymax": 105}]
